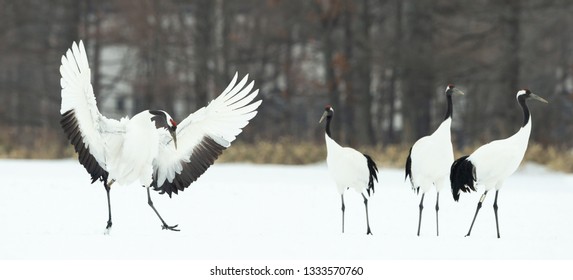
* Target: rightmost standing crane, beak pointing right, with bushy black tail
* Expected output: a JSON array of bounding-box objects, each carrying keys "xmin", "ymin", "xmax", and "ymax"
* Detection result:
[{"xmin": 450, "ymin": 89, "xmax": 547, "ymax": 238}]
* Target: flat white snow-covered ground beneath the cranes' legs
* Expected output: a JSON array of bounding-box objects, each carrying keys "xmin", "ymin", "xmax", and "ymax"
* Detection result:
[{"xmin": 0, "ymin": 159, "xmax": 573, "ymax": 260}]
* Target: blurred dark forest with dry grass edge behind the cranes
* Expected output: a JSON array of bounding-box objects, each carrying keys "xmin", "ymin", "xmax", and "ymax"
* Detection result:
[{"xmin": 0, "ymin": 0, "xmax": 573, "ymax": 172}]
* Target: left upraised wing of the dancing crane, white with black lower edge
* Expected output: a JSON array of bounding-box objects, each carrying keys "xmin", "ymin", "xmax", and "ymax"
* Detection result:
[{"xmin": 60, "ymin": 41, "xmax": 121, "ymax": 183}]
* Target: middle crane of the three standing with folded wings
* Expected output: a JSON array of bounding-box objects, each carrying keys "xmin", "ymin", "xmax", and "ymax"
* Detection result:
[{"xmin": 404, "ymin": 84, "xmax": 464, "ymax": 236}]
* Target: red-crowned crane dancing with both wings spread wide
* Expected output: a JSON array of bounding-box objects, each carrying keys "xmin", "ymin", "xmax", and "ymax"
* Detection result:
[{"xmin": 60, "ymin": 41, "xmax": 261, "ymax": 233}]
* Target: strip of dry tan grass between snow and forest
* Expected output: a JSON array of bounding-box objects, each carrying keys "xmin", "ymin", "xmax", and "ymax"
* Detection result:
[{"xmin": 0, "ymin": 131, "xmax": 573, "ymax": 173}]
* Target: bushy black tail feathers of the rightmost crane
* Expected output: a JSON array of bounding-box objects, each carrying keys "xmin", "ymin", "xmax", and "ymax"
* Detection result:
[{"xmin": 450, "ymin": 156, "xmax": 476, "ymax": 201}]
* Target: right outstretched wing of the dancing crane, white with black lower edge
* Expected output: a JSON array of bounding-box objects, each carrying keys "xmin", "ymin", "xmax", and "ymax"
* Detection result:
[{"xmin": 152, "ymin": 74, "xmax": 262, "ymax": 196}]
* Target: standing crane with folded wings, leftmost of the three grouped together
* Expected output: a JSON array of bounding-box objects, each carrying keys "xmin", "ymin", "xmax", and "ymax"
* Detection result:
[{"xmin": 319, "ymin": 105, "xmax": 378, "ymax": 235}]
